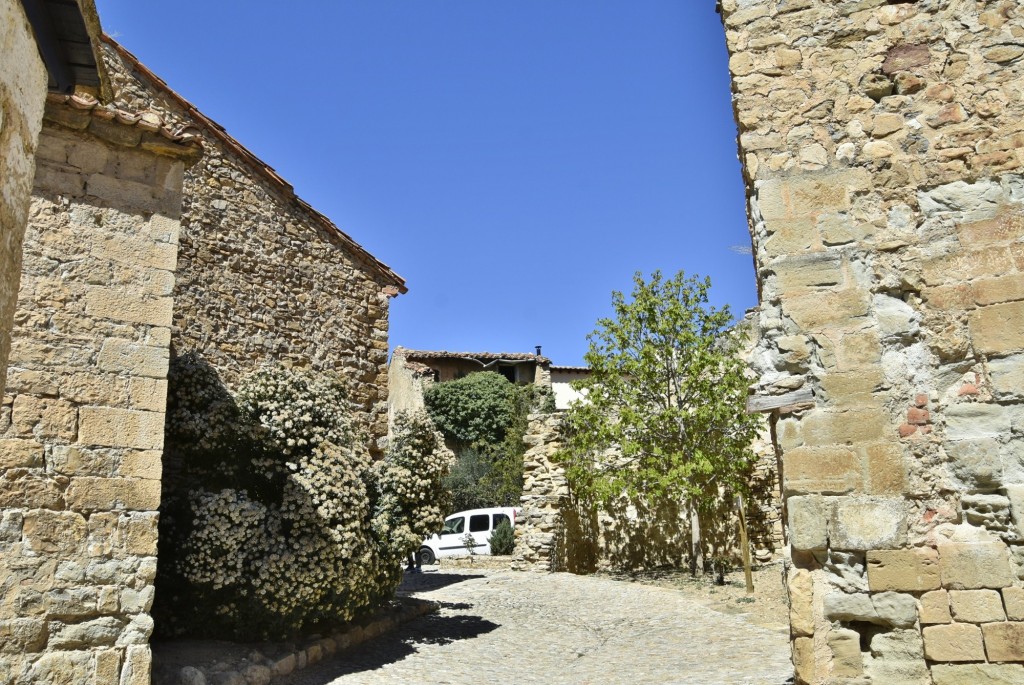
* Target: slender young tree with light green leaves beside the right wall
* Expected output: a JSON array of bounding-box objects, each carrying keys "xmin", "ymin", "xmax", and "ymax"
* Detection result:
[{"xmin": 556, "ymin": 271, "xmax": 761, "ymax": 572}]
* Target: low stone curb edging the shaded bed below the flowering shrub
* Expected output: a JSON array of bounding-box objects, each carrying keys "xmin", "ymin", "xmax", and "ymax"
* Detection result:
[{"xmin": 153, "ymin": 597, "xmax": 438, "ymax": 685}]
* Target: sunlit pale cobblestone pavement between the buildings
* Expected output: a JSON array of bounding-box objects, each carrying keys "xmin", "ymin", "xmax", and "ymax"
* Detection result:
[{"xmin": 274, "ymin": 569, "xmax": 793, "ymax": 685}]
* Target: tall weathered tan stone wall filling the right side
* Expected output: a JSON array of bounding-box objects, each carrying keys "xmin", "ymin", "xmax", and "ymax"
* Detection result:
[{"xmin": 721, "ymin": 0, "xmax": 1024, "ymax": 684}]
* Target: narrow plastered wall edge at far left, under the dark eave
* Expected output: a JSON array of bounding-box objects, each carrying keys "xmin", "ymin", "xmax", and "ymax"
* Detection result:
[{"xmin": 0, "ymin": 0, "xmax": 47, "ymax": 394}]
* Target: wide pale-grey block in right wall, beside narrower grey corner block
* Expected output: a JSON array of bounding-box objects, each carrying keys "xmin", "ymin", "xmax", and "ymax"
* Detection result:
[{"xmin": 828, "ymin": 497, "xmax": 906, "ymax": 551}]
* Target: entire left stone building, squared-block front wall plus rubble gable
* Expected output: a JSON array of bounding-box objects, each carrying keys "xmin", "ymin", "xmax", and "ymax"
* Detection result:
[{"xmin": 0, "ymin": 5, "xmax": 404, "ymax": 685}]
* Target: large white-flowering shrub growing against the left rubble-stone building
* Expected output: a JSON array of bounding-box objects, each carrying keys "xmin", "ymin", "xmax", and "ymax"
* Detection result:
[{"xmin": 154, "ymin": 358, "xmax": 453, "ymax": 639}]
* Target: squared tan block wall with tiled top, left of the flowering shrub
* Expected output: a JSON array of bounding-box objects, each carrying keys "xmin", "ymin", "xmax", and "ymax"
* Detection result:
[{"xmin": 0, "ymin": 97, "xmax": 199, "ymax": 685}]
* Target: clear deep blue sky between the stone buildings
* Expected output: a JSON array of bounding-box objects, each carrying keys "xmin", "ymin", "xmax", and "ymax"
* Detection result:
[{"xmin": 96, "ymin": 0, "xmax": 757, "ymax": 365}]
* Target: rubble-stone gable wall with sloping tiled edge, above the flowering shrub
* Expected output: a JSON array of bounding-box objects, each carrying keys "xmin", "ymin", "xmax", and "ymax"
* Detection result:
[{"xmin": 97, "ymin": 39, "xmax": 406, "ymax": 455}]
